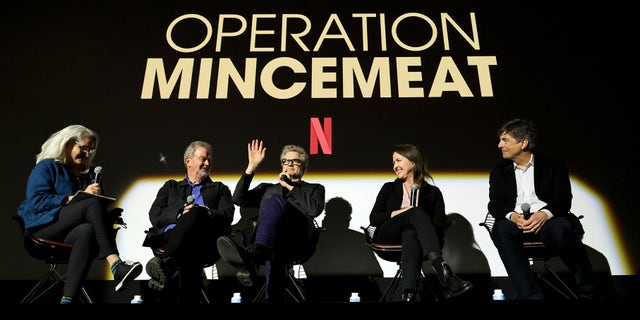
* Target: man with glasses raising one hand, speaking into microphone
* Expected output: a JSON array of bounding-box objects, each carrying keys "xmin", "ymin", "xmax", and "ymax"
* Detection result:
[{"xmin": 218, "ymin": 139, "xmax": 325, "ymax": 303}]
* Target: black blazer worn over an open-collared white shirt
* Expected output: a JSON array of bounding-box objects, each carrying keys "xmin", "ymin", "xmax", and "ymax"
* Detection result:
[{"xmin": 488, "ymin": 153, "xmax": 573, "ymax": 219}]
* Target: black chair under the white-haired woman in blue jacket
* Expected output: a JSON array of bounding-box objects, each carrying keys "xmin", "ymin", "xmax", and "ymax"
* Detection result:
[{"xmin": 13, "ymin": 215, "xmax": 93, "ymax": 304}]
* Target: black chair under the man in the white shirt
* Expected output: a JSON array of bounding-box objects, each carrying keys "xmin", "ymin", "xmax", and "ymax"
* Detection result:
[{"xmin": 479, "ymin": 213, "xmax": 584, "ymax": 299}]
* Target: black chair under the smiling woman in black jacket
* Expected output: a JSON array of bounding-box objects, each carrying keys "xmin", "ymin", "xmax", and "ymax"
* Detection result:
[{"xmin": 360, "ymin": 225, "xmax": 438, "ymax": 302}]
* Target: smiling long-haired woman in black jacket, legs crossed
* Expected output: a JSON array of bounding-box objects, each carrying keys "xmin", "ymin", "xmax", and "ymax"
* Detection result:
[{"xmin": 369, "ymin": 144, "xmax": 473, "ymax": 302}]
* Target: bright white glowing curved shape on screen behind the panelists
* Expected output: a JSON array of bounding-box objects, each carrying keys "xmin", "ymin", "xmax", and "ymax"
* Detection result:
[{"xmin": 109, "ymin": 173, "xmax": 633, "ymax": 280}]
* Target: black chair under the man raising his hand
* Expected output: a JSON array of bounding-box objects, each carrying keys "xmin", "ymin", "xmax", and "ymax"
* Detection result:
[{"xmin": 253, "ymin": 220, "xmax": 325, "ymax": 303}]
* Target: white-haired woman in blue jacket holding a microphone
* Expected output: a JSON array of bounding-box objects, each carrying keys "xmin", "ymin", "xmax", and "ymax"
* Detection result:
[{"xmin": 18, "ymin": 125, "xmax": 142, "ymax": 304}]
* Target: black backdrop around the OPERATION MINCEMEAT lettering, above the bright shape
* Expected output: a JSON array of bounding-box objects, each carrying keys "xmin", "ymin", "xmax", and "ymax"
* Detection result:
[{"xmin": 0, "ymin": 1, "xmax": 640, "ymax": 279}]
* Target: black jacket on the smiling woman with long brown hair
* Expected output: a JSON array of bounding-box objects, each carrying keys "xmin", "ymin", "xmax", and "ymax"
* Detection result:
[{"xmin": 369, "ymin": 179, "xmax": 448, "ymax": 238}]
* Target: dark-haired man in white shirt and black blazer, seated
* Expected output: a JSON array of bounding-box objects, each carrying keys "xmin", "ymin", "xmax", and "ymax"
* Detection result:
[{"xmin": 488, "ymin": 119, "xmax": 596, "ymax": 299}]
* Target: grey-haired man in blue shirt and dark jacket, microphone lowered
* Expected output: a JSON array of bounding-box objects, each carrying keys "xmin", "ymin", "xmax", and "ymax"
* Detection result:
[{"xmin": 143, "ymin": 141, "xmax": 235, "ymax": 303}]
